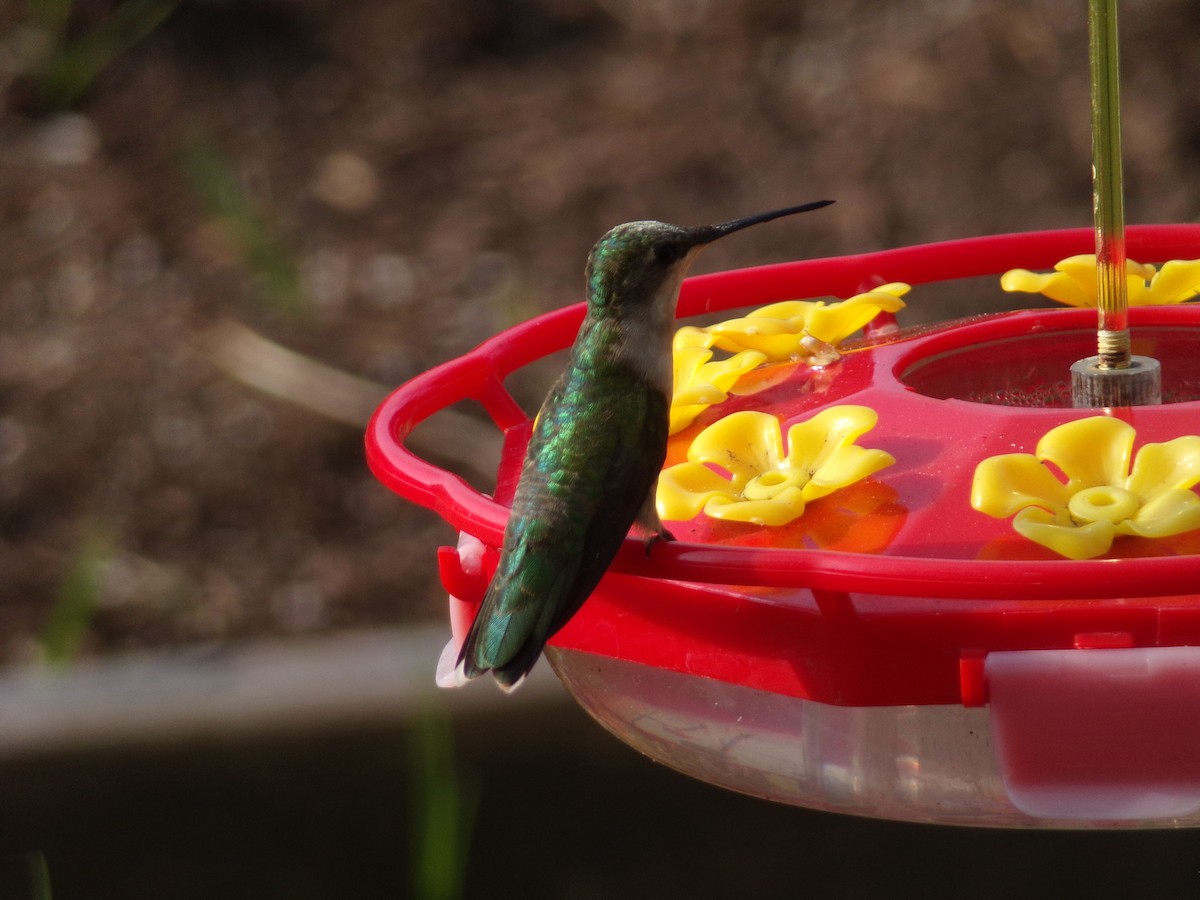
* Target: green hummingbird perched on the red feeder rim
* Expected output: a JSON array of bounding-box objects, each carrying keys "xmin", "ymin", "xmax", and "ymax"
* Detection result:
[{"xmin": 445, "ymin": 200, "xmax": 833, "ymax": 690}]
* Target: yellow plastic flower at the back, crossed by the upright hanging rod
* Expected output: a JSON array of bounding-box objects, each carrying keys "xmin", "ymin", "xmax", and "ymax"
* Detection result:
[{"xmin": 1000, "ymin": 253, "xmax": 1200, "ymax": 306}]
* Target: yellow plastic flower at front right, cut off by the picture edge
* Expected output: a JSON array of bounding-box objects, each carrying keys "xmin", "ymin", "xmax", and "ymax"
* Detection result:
[{"xmin": 971, "ymin": 415, "xmax": 1200, "ymax": 559}]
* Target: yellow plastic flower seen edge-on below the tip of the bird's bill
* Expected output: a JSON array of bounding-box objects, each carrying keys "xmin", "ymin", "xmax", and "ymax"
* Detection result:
[{"xmin": 707, "ymin": 282, "xmax": 910, "ymax": 361}]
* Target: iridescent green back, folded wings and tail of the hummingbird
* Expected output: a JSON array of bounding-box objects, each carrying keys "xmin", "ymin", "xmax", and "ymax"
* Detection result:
[{"xmin": 458, "ymin": 379, "xmax": 668, "ymax": 689}]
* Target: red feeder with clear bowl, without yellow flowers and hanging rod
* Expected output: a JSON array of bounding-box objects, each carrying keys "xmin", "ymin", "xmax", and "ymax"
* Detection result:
[{"xmin": 367, "ymin": 226, "xmax": 1200, "ymax": 827}]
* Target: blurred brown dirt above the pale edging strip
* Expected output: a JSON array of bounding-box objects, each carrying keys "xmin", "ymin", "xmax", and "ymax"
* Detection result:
[{"xmin": 0, "ymin": 0, "xmax": 1200, "ymax": 662}]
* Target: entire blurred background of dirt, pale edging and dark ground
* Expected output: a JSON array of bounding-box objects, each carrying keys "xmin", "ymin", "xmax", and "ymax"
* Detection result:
[{"xmin": 0, "ymin": 0, "xmax": 1200, "ymax": 899}]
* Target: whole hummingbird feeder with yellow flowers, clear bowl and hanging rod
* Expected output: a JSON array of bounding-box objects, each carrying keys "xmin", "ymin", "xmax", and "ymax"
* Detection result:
[{"xmin": 367, "ymin": 0, "xmax": 1200, "ymax": 828}]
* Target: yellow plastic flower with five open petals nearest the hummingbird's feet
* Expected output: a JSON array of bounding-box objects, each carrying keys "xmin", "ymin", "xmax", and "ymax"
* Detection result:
[{"xmin": 658, "ymin": 406, "xmax": 895, "ymax": 526}]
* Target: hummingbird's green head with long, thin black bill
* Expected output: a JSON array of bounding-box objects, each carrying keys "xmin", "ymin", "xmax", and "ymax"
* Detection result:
[{"xmin": 586, "ymin": 200, "xmax": 833, "ymax": 318}]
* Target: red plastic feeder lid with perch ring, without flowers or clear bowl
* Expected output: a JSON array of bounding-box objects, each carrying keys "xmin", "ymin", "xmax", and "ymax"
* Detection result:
[{"xmin": 367, "ymin": 226, "xmax": 1200, "ymax": 706}]
